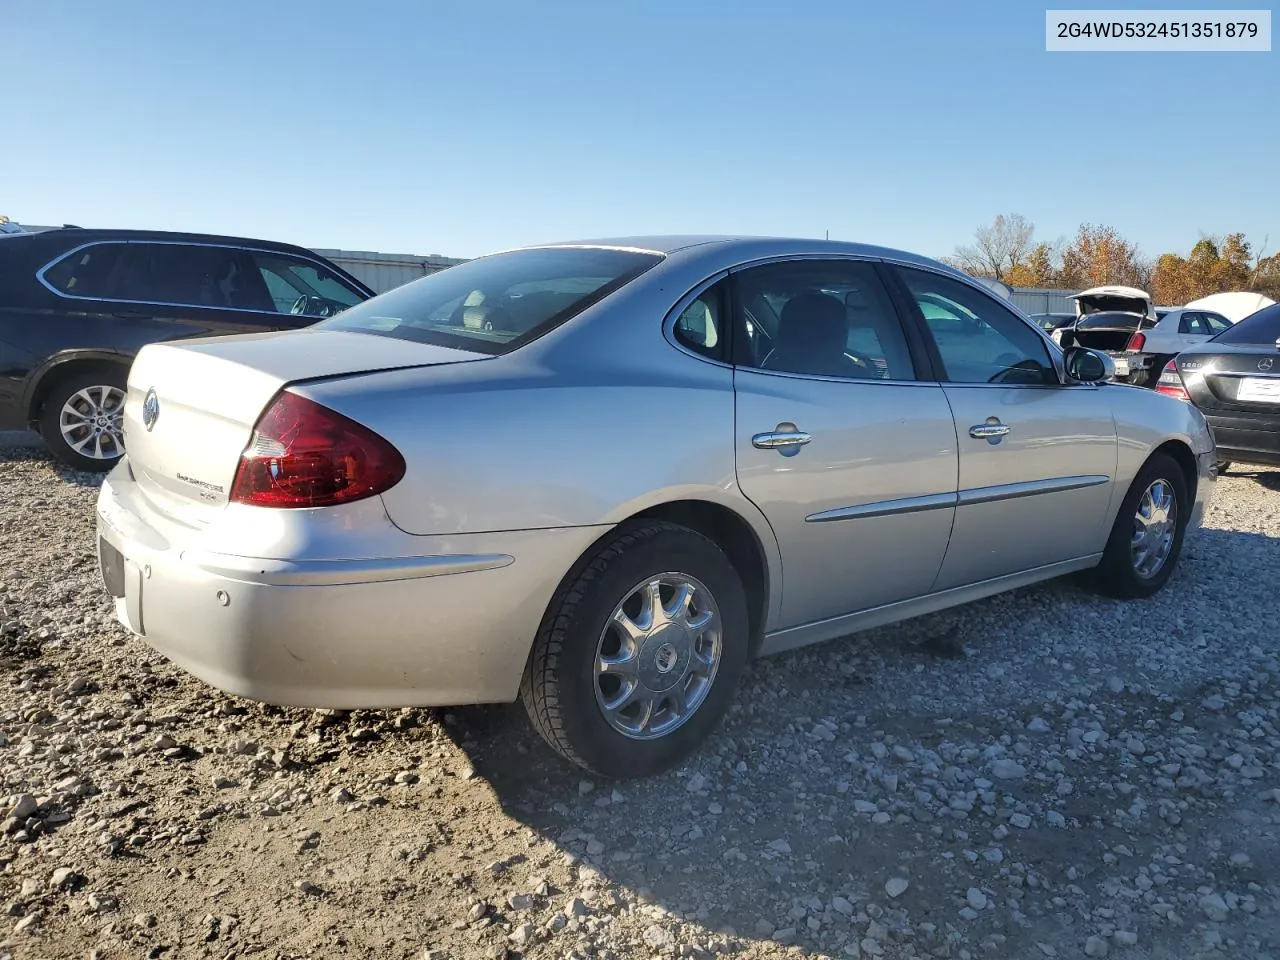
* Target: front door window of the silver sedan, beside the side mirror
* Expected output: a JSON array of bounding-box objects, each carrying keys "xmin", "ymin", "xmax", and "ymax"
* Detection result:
[{"xmin": 896, "ymin": 268, "xmax": 1059, "ymax": 384}]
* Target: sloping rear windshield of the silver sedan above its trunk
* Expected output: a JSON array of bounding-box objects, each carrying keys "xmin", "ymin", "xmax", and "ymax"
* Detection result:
[{"xmin": 312, "ymin": 247, "xmax": 662, "ymax": 353}]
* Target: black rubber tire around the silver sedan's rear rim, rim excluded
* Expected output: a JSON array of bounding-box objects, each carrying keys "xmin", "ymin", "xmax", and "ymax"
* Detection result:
[{"xmin": 520, "ymin": 521, "xmax": 750, "ymax": 780}]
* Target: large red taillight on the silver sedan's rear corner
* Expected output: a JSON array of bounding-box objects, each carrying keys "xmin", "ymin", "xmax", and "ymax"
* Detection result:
[{"xmin": 230, "ymin": 393, "xmax": 404, "ymax": 507}]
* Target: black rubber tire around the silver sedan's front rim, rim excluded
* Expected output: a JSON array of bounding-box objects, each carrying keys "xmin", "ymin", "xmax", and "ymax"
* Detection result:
[{"xmin": 1093, "ymin": 453, "xmax": 1192, "ymax": 599}]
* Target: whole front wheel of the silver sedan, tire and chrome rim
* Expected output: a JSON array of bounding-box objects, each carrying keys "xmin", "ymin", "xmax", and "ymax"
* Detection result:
[{"xmin": 1094, "ymin": 453, "xmax": 1190, "ymax": 599}]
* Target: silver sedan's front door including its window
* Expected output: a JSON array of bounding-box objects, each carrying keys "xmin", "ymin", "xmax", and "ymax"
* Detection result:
[{"xmin": 893, "ymin": 266, "xmax": 1119, "ymax": 590}]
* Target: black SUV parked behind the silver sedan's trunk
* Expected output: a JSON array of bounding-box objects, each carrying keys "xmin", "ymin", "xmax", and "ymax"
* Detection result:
[{"xmin": 0, "ymin": 227, "xmax": 374, "ymax": 470}]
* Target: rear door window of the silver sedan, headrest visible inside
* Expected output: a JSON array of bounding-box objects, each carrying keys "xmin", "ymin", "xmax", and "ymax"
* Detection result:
[{"xmin": 733, "ymin": 260, "xmax": 915, "ymax": 380}]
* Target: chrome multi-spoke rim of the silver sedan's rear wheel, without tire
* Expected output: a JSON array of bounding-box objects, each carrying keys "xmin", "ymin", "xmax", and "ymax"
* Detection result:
[{"xmin": 595, "ymin": 573, "xmax": 724, "ymax": 740}]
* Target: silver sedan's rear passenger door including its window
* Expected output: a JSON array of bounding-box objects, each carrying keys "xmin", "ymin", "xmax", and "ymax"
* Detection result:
[{"xmin": 731, "ymin": 259, "xmax": 956, "ymax": 628}]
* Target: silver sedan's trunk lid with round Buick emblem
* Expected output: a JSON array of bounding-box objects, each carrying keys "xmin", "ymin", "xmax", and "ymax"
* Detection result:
[{"xmin": 124, "ymin": 329, "xmax": 488, "ymax": 526}]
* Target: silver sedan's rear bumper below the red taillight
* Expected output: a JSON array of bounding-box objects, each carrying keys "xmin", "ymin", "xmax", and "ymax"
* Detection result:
[{"xmin": 97, "ymin": 463, "xmax": 602, "ymax": 709}]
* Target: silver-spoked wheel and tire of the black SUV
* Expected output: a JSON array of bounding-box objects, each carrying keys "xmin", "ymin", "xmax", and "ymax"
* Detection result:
[{"xmin": 40, "ymin": 367, "xmax": 128, "ymax": 472}]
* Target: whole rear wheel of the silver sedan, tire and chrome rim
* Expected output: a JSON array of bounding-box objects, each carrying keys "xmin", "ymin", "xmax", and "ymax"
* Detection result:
[{"xmin": 521, "ymin": 522, "xmax": 749, "ymax": 778}]
